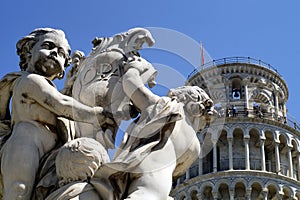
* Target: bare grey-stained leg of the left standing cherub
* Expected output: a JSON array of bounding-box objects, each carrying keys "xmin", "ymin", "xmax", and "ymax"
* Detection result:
[{"xmin": 1, "ymin": 122, "xmax": 55, "ymax": 200}]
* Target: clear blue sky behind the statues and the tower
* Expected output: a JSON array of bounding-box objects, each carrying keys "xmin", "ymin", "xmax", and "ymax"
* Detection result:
[{"xmin": 0, "ymin": 0, "xmax": 300, "ymax": 121}]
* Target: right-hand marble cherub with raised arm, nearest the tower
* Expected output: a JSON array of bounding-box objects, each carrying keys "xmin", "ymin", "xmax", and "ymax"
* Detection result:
[{"xmin": 103, "ymin": 60, "xmax": 215, "ymax": 200}]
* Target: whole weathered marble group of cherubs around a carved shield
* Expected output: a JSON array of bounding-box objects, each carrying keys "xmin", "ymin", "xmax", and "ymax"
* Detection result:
[{"xmin": 0, "ymin": 28, "xmax": 214, "ymax": 200}]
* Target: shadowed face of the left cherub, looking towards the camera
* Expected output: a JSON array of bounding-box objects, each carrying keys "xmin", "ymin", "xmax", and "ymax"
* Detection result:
[{"xmin": 28, "ymin": 32, "xmax": 70, "ymax": 79}]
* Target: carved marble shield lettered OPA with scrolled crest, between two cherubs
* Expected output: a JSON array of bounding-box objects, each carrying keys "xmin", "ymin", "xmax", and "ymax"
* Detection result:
[{"xmin": 70, "ymin": 28, "xmax": 157, "ymax": 146}]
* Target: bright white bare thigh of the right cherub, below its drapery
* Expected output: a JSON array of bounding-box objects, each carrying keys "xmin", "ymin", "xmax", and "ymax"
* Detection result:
[{"xmin": 125, "ymin": 162, "xmax": 174, "ymax": 200}]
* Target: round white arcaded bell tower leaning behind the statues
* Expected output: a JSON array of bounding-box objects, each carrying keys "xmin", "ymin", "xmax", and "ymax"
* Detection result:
[{"xmin": 171, "ymin": 57, "xmax": 300, "ymax": 200}]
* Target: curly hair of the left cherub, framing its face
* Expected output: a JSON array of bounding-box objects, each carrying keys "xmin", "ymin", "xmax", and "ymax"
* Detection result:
[{"xmin": 16, "ymin": 28, "xmax": 71, "ymax": 71}]
